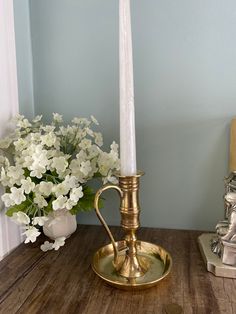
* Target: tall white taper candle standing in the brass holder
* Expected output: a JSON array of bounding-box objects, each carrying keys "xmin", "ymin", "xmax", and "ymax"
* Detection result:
[{"xmin": 119, "ymin": 0, "xmax": 137, "ymax": 176}]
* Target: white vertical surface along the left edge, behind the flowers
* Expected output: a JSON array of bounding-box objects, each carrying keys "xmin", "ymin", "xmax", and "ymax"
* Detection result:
[{"xmin": 0, "ymin": 0, "xmax": 22, "ymax": 260}]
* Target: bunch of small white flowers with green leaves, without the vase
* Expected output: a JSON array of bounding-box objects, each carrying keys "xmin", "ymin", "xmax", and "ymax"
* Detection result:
[{"xmin": 0, "ymin": 113, "xmax": 119, "ymax": 251}]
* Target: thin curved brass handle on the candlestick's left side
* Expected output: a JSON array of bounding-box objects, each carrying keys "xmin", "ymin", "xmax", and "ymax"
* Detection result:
[{"xmin": 94, "ymin": 184, "xmax": 123, "ymax": 265}]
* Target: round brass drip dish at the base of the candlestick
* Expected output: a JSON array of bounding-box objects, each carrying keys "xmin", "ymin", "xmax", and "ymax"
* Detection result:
[{"xmin": 92, "ymin": 241, "xmax": 172, "ymax": 290}]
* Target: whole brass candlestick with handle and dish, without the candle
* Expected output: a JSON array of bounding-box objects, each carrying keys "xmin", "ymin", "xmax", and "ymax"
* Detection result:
[{"xmin": 92, "ymin": 172, "xmax": 172, "ymax": 290}]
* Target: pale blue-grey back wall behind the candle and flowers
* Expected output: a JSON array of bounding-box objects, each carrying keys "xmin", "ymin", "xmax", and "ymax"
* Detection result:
[{"xmin": 13, "ymin": 0, "xmax": 236, "ymax": 229}]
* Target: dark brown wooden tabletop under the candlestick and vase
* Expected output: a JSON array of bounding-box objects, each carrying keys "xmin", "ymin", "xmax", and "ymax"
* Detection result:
[{"xmin": 0, "ymin": 225, "xmax": 236, "ymax": 314}]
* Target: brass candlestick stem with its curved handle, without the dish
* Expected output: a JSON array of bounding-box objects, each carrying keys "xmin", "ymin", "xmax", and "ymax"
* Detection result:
[{"xmin": 95, "ymin": 173, "xmax": 148, "ymax": 278}]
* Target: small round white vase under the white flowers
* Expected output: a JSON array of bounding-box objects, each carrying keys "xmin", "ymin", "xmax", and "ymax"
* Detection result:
[{"xmin": 43, "ymin": 209, "xmax": 77, "ymax": 240}]
